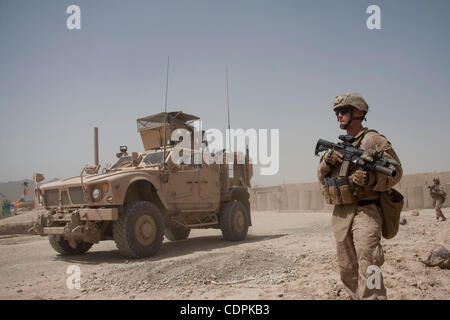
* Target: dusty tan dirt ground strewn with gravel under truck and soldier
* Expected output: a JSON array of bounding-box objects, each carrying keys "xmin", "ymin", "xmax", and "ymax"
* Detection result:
[{"xmin": 0, "ymin": 209, "xmax": 450, "ymax": 300}]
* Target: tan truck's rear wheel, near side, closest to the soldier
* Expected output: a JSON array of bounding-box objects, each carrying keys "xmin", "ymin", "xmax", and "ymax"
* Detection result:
[{"xmin": 219, "ymin": 201, "xmax": 249, "ymax": 241}]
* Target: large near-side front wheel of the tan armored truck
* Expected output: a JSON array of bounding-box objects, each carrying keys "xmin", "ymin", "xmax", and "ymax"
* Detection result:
[{"xmin": 113, "ymin": 201, "xmax": 164, "ymax": 258}]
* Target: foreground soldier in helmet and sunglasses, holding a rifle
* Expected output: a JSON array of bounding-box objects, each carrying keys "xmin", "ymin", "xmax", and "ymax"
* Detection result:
[{"xmin": 318, "ymin": 93, "xmax": 402, "ymax": 299}]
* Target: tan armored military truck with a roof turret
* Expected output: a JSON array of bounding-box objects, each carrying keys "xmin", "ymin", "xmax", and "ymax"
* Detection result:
[{"xmin": 32, "ymin": 111, "xmax": 253, "ymax": 258}]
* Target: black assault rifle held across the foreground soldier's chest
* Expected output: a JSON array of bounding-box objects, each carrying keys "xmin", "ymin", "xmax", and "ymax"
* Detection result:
[{"xmin": 314, "ymin": 135, "xmax": 401, "ymax": 177}]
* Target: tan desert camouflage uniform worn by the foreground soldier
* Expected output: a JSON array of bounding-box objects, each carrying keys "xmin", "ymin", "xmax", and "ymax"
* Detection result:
[{"xmin": 318, "ymin": 128, "xmax": 402, "ymax": 299}]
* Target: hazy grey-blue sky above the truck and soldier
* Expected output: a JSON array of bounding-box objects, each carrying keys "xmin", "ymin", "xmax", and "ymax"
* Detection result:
[{"xmin": 0, "ymin": 0, "xmax": 450, "ymax": 185}]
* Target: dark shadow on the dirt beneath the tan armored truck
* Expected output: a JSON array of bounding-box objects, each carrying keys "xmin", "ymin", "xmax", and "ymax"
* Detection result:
[{"xmin": 55, "ymin": 234, "xmax": 287, "ymax": 264}]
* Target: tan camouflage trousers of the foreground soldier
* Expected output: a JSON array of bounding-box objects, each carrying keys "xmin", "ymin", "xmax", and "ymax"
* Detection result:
[{"xmin": 336, "ymin": 204, "xmax": 386, "ymax": 300}]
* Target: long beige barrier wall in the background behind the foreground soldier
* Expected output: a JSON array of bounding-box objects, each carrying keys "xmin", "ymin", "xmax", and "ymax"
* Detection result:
[{"xmin": 250, "ymin": 171, "xmax": 450, "ymax": 211}]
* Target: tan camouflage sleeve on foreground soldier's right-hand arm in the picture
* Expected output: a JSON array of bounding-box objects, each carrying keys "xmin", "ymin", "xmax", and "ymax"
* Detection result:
[{"xmin": 369, "ymin": 133, "xmax": 403, "ymax": 192}]
